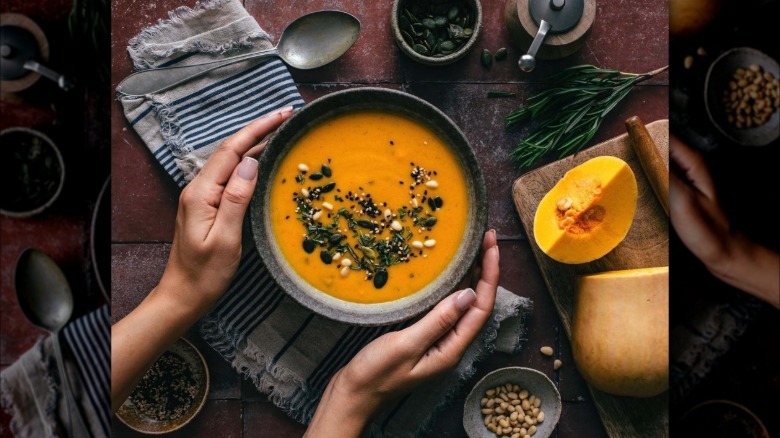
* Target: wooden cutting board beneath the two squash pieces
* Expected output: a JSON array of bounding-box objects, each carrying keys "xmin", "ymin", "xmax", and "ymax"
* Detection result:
[{"xmin": 512, "ymin": 119, "xmax": 669, "ymax": 438}]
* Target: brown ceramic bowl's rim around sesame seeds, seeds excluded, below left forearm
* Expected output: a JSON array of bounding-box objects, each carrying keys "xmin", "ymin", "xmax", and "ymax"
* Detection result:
[{"xmin": 116, "ymin": 338, "xmax": 210, "ymax": 435}]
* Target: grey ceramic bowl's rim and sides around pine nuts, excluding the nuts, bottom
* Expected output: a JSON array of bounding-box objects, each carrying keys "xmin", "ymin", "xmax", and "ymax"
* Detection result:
[{"xmin": 463, "ymin": 367, "xmax": 561, "ymax": 438}]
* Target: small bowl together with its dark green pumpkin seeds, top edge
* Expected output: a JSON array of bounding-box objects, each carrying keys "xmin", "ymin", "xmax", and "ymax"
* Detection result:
[{"xmin": 391, "ymin": 0, "xmax": 482, "ymax": 66}]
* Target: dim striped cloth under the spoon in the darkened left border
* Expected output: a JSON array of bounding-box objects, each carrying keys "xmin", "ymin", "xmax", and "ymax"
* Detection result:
[{"xmin": 0, "ymin": 304, "xmax": 111, "ymax": 438}]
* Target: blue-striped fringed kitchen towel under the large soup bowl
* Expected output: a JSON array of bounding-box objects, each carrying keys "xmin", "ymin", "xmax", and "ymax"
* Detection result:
[{"xmin": 120, "ymin": 0, "xmax": 532, "ymax": 437}]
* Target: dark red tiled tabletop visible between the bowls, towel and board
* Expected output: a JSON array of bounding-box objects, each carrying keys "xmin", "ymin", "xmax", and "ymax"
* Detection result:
[{"xmin": 111, "ymin": 0, "xmax": 668, "ymax": 432}]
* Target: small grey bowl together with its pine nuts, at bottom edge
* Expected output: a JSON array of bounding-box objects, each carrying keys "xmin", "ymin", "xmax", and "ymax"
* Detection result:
[{"xmin": 463, "ymin": 367, "xmax": 561, "ymax": 438}]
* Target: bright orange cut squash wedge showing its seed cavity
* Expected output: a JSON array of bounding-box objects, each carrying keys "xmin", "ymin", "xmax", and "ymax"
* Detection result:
[{"xmin": 534, "ymin": 156, "xmax": 637, "ymax": 264}]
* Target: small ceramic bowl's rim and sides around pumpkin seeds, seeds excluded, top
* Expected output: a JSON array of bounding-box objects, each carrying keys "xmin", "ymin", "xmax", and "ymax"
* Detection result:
[{"xmin": 390, "ymin": 0, "xmax": 482, "ymax": 66}]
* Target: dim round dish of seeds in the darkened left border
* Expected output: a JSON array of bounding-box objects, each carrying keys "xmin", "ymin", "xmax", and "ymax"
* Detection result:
[{"xmin": 0, "ymin": 127, "xmax": 65, "ymax": 218}]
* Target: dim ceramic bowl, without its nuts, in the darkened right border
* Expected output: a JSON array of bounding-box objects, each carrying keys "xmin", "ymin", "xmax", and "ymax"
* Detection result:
[{"xmin": 704, "ymin": 47, "xmax": 780, "ymax": 146}]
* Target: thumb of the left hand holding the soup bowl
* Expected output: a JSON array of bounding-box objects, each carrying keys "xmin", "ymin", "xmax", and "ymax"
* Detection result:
[{"xmin": 213, "ymin": 157, "xmax": 257, "ymax": 236}]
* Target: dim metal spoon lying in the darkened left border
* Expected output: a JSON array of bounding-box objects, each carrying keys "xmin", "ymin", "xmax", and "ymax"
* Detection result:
[{"xmin": 14, "ymin": 248, "xmax": 90, "ymax": 438}]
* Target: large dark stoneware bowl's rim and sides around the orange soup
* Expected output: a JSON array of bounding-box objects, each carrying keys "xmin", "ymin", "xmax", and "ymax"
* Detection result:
[{"xmin": 250, "ymin": 88, "xmax": 487, "ymax": 326}]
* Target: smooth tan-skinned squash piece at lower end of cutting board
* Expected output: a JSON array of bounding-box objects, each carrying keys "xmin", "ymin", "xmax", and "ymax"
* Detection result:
[{"xmin": 571, "ymin": 267, "xmax": 669, "ymax": 397}]
